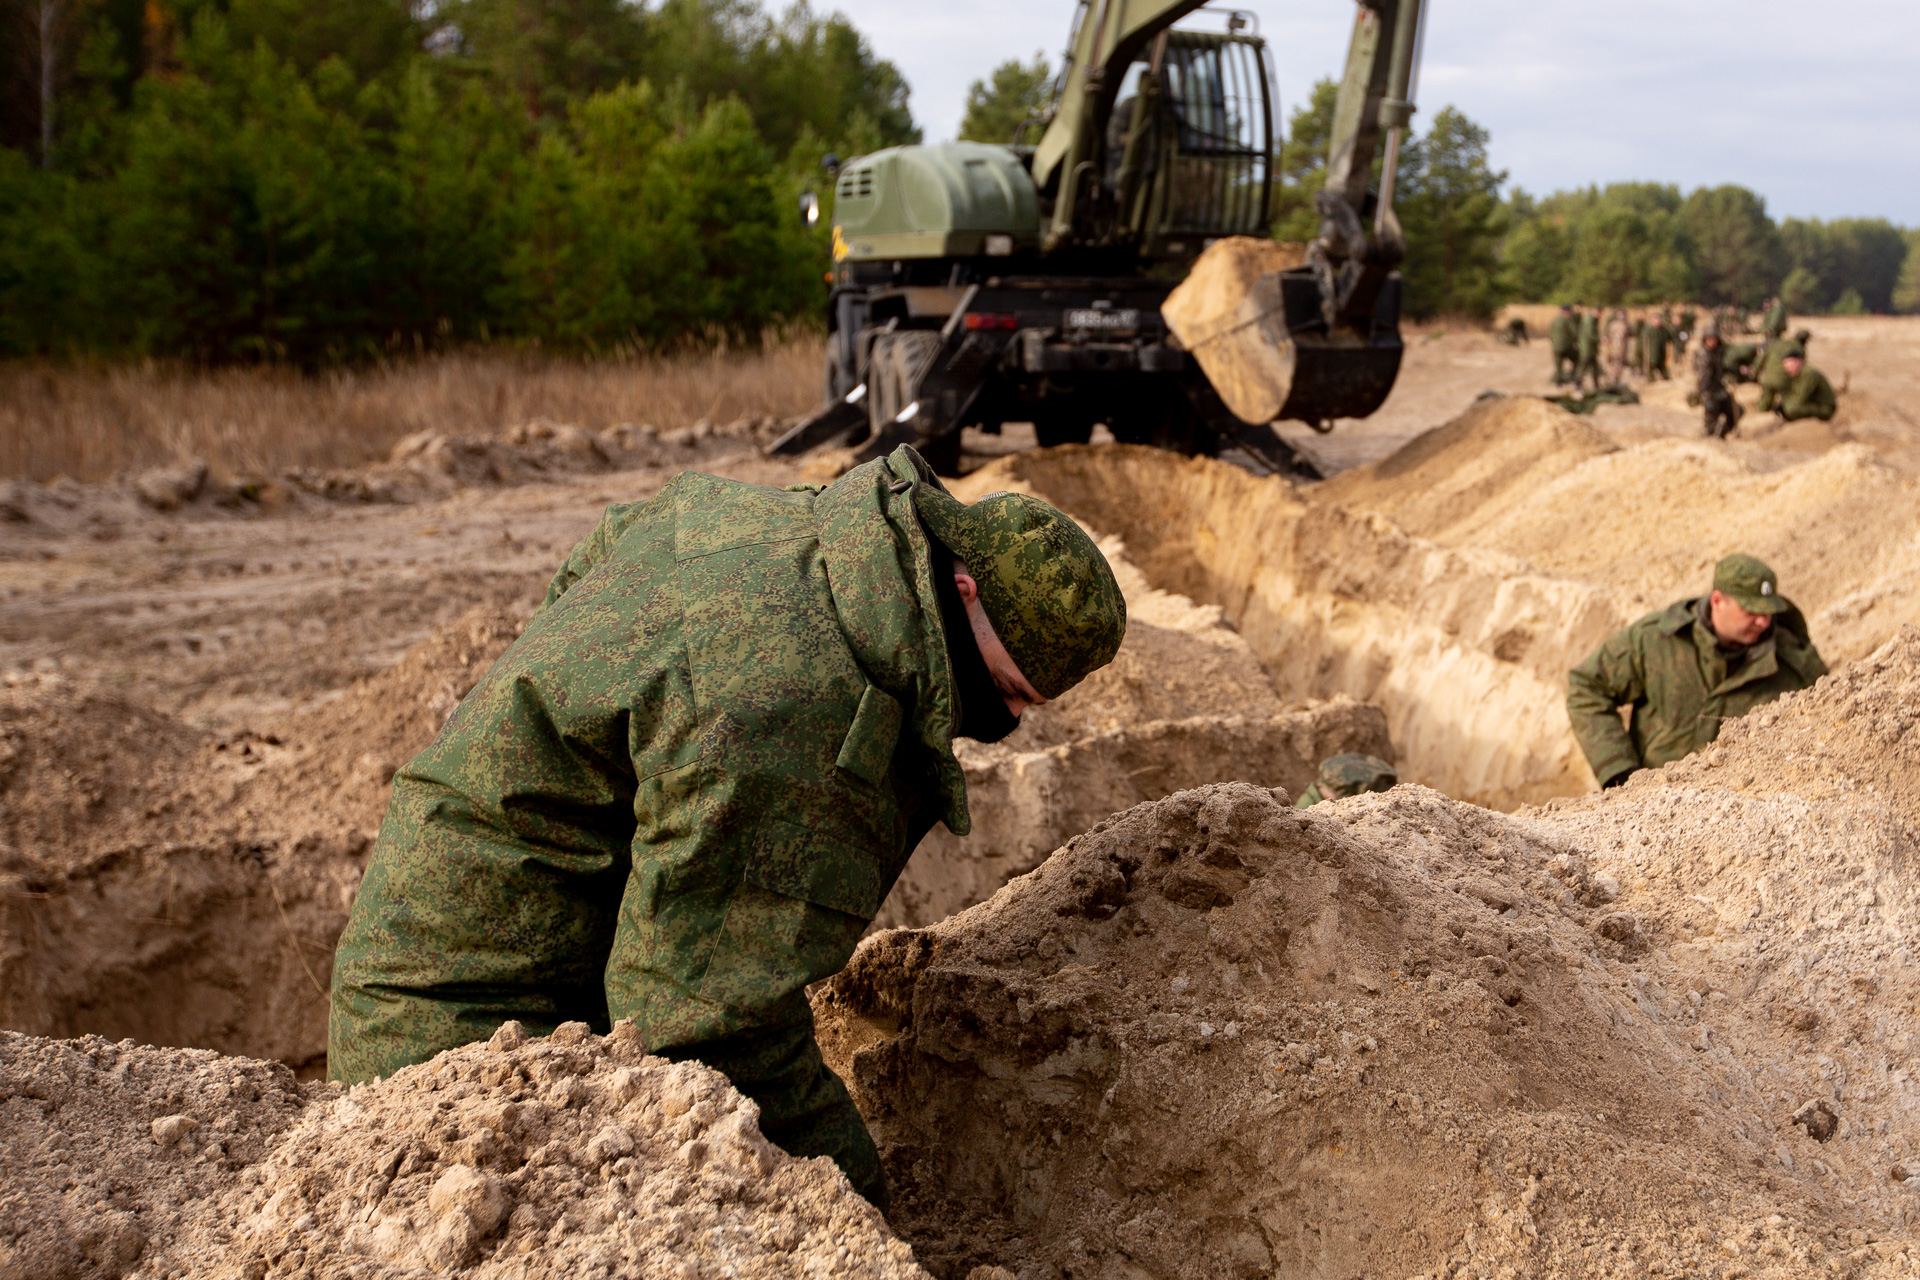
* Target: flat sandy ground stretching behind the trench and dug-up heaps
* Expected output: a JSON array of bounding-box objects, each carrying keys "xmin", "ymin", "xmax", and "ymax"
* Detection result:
[{"xmin": 0, "ymin": 317, "xmax": 1920, "ymax": 727}]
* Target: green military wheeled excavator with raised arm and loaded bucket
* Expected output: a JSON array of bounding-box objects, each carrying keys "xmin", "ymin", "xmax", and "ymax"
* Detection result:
[{"xmin": 768, "ymin": 0, "xmax": 1423, "ymax": 476}]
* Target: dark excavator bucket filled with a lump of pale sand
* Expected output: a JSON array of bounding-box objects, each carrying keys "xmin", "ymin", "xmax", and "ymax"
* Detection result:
[{"xmin": 1160, "ymin": 236, "xmax": 1402, "ymax": 430}]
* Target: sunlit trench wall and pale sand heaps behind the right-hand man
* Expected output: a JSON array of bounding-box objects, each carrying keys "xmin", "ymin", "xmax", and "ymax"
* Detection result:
[{"xmin": 966, "ymin": 397, "xmax": 1920, "ymax": 808}]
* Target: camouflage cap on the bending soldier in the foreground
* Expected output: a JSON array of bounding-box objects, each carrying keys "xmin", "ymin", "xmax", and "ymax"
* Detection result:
[{"xmin": 914, "ymin": 484, "xmax": 1127, "ymax": 699}]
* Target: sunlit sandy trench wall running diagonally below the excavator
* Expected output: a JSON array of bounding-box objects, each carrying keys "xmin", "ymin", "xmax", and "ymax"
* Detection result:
[{"xmin": 975, "ymin": 445, "xmax": 1628, "ymax": 810}]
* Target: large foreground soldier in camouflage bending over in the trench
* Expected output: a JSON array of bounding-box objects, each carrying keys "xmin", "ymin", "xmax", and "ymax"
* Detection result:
[{"xmin": 328, "ymin": 447, "xmax": 1127, "ymax": 1207}]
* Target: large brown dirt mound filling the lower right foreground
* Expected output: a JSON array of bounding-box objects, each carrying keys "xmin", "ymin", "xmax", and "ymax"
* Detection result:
[{"xmin": 816, "ymin": 629, "xmax": 1920, "ymax": 1276}]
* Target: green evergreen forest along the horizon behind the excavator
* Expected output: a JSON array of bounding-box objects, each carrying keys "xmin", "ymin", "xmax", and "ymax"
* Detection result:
[{"xmin": 0, "ymin": 0, "xmax": 1920, "ymax": 368}]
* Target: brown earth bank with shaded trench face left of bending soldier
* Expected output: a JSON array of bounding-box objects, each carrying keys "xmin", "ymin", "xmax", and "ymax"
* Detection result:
[{"xmin": 0, "ymin": 608, "xmax": 520, "ymax": 1069}]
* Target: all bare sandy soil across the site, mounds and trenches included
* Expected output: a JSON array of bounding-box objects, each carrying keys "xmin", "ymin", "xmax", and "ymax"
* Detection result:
[{"xmin": 0, "ymin": 319, "xmax": 1920, "ymax": 1280}]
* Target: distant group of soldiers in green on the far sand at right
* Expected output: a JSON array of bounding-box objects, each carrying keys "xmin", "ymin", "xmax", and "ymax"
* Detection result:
[{"xmin": 1536, "ymin": 297, "xmax": 1837, "ymax": 439}]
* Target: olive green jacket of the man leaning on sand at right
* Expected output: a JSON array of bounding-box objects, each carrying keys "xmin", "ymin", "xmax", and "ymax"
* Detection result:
[{"xmin": 1567, "ymin": 597, "xmax": 1826, "ymax": 785}]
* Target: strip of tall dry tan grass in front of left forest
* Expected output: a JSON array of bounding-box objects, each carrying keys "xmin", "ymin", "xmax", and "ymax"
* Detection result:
[{"xmin": 0, "ymin": 332, "xmax": 822, "ymax": 480}]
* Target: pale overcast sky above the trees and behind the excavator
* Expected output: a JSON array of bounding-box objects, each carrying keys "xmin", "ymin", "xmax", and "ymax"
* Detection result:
[{"xmin": 833, "ymin": 0, "xmax": 1920, "ymax": 226}]
